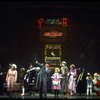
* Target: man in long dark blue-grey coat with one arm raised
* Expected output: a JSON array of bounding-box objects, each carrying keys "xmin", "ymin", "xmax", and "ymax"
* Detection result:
[{"xmin": 36, "ymin": 61, "xmax": 51, "ymax": 98}]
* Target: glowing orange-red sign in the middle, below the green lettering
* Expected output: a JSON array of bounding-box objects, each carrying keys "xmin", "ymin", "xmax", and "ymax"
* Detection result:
[{"xmin": 40, "ymin": 25, "xmax": 67, "ymax": 42}]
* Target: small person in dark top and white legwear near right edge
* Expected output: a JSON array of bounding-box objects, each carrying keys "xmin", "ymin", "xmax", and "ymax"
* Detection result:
[{"xmin": 86, "ymin": 73, "xmax": 93, "ymax": 95}]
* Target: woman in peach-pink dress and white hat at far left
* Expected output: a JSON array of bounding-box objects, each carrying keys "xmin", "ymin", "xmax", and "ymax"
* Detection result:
[{"xmin": 6, "ymin": 64, "xmax": 17, "ymax": 96}]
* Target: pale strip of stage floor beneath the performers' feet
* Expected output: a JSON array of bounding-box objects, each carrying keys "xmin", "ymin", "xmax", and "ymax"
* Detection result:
[{"xmin": 0, "ymin": 93, "xmax": 100, "ymax": 99}]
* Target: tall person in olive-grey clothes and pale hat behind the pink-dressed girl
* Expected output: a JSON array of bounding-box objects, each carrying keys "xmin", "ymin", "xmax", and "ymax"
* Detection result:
[{"xmin": 60, "ymin": 61, "xmax": 69, "ymax": 97}]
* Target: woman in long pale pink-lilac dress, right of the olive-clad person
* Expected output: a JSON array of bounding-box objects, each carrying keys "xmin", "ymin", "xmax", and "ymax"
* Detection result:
[{"xmin": 68, "ymin": 64, "xmax": 77, "ymax": 95}]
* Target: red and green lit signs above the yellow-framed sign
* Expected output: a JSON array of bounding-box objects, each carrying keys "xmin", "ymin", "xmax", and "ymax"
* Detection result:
[{"xmin": 37, "ymin": 18, "xmax": 68, "ymax": 42}]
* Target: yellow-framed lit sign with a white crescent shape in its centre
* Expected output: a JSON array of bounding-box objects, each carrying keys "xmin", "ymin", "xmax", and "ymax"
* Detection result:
[{"xmin": 44, "ymin": 44, "xmax": 62, "ymax": 66}]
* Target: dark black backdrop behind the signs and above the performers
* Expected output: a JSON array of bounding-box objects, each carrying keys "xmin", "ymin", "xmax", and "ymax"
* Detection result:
[{"xmin": 0, "ymin": 1, "xmax": 100, "ymax": 72}]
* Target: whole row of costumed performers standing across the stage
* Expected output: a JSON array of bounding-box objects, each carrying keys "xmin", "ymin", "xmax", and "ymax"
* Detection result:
[{"xmin": 0, "ymin": 61, "xmax": 100, "ymax": 98}]
